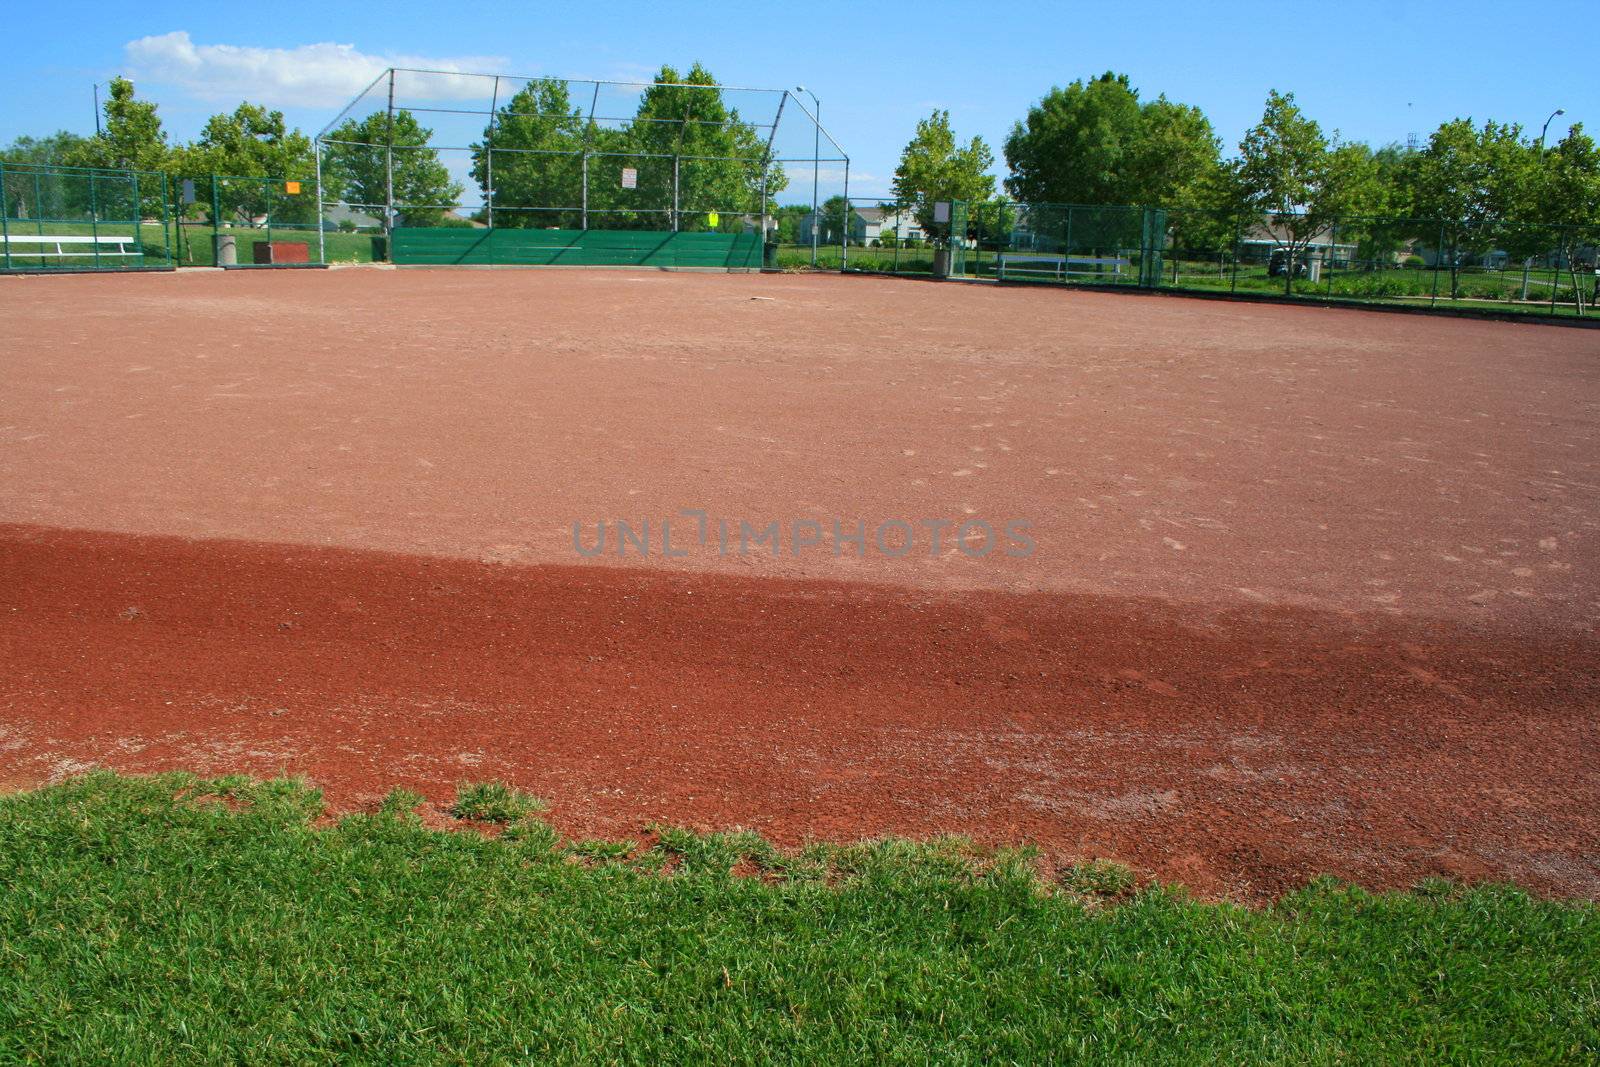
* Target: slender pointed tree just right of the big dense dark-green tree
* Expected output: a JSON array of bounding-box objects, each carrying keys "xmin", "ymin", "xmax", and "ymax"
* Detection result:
[{"xmin": 1235, "ymin": 90, "xmax": 1357, "ymax": 293}]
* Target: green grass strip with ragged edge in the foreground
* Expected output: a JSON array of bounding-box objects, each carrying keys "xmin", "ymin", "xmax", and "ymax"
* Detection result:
[{"xmin": 0, "ymin": 774, "xmax": 1600, "ymax": 1064}]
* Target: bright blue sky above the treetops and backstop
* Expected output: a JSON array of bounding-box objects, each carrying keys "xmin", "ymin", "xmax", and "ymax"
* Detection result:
[{"xmin": 0, "ymin": 0, "xmax": 1600, "ymax": 200}]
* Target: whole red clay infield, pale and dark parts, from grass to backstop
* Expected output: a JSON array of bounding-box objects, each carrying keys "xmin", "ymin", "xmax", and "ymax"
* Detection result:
[{"xmin": 0, "ymin": 270, "xmax": 1600, "ymax": 899}]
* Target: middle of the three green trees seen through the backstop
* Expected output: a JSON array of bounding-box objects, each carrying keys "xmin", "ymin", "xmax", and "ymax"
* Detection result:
[{"xmin": 472, "ymin": 78, "xmax": 592, "ymax": 229}]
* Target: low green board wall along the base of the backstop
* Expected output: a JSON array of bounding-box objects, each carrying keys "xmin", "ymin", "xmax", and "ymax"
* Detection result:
[{"xmin": 394, "ymin": 227, "xmax": 762, "ymax": 270}]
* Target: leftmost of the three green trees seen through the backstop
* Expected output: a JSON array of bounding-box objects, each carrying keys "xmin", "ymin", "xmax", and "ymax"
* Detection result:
[{"xmin": 322, "ymin": 110, "xmax": 462, "ymax": 229}]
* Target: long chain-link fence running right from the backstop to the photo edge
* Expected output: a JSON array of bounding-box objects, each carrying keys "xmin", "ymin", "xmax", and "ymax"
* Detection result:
[{"xmin": 800, "ymin": 197, "xmax": 1600, "ymax": 315}]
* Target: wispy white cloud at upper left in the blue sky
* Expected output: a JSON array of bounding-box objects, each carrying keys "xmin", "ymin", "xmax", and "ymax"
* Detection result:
[{"xmin": 123, "ymin": 30, "xmax": 506, "ymax": 107}]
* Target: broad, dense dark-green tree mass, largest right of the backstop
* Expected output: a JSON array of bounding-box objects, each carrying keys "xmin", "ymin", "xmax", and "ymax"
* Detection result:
[{"xmin": 1005, "ymin": 70, "xmax": 1219, "ymax": 206}]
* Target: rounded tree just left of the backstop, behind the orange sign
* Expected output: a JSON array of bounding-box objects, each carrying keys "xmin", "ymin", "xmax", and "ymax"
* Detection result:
[{"xmin": 178, "ymin": 101, "xmax": 317, "ymax": 226}]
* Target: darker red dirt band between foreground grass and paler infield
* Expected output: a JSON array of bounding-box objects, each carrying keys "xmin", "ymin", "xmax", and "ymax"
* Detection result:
[{"xmin": 0, "ymin": 526, "xmax": 1600, "ymax": 899}]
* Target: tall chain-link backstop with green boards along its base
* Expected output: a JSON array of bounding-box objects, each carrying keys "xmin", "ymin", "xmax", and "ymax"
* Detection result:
[{"xmin": 315, "ymin": 67, "xmax": 850, "ymax": 266}]
